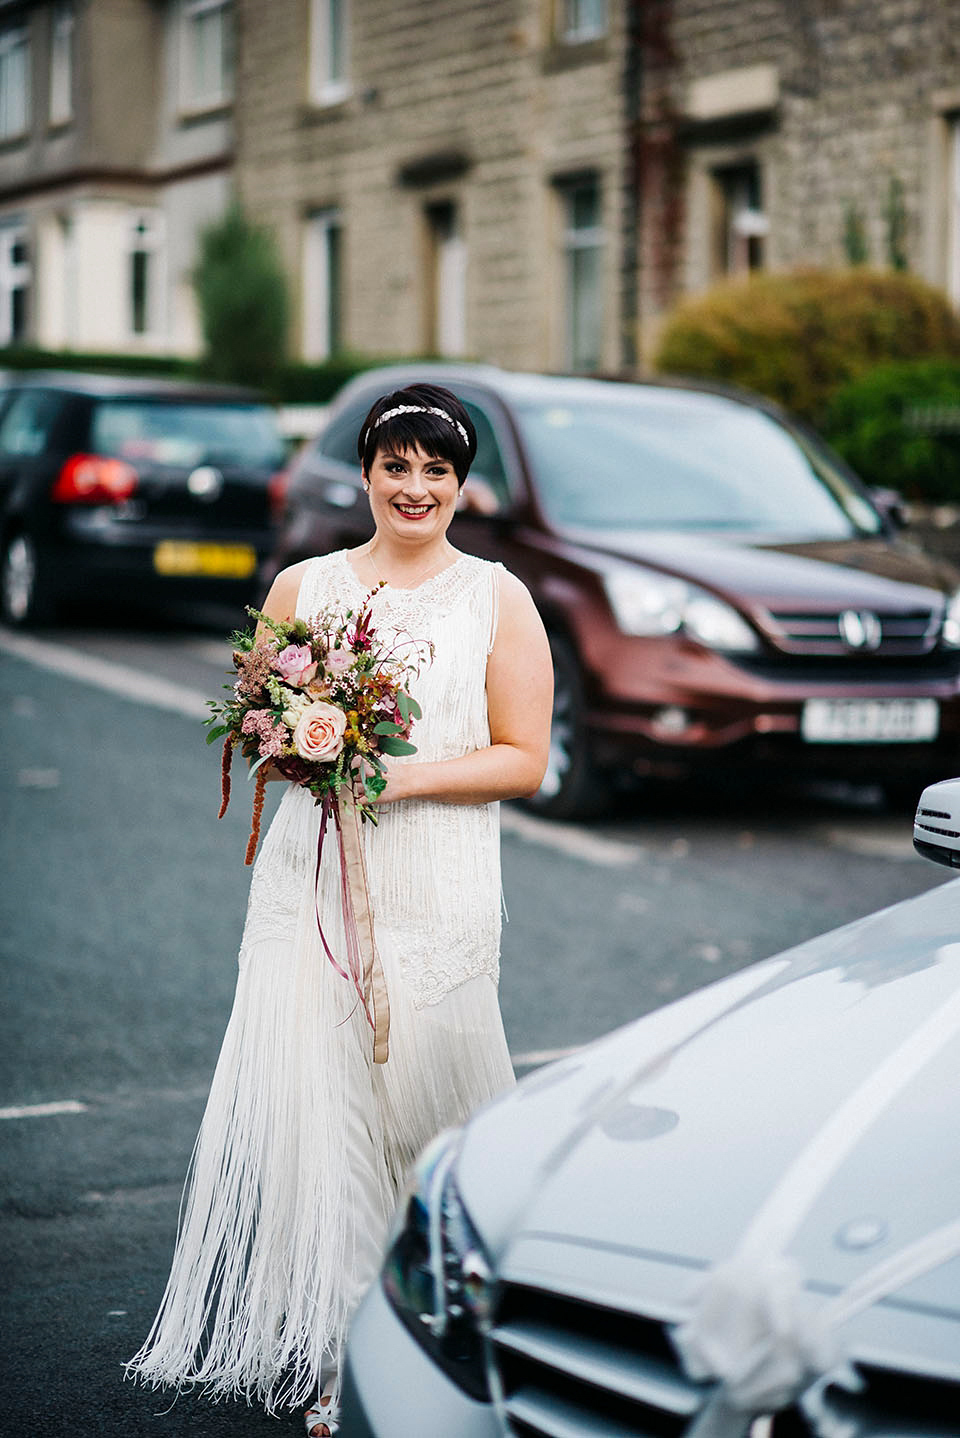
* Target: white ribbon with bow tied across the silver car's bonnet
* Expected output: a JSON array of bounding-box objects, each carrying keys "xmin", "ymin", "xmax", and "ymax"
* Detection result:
[{"xmin": 673, "ymin": 943, "xmax": 960, "ymax": 1438}]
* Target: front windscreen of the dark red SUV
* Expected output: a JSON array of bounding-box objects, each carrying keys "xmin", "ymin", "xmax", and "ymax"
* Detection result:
[{"xmin": 516, "ymin": 390, "xmax": 882, "ymax": 539}]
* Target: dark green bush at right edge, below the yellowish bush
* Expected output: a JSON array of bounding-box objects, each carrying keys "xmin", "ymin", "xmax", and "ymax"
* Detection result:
[{"xmin": 823, "ymin": 360, "xmax": 960, "ymax": 503}]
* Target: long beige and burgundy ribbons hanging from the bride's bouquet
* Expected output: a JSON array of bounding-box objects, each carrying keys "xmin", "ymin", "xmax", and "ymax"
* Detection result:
[{"xmin": 313, "ymin": 794, "xmax": 389, "ymax": 1064}]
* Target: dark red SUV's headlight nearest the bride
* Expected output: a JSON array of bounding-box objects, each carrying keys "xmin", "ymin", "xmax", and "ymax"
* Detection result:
[{"xmin": 604, "ymin": 568, "xmax": 758, "ymax": 654}]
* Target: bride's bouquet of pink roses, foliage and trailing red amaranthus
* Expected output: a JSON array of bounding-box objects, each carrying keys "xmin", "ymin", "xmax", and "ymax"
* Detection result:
[{"xmin": 207, "ymin": 585, "xmax": 433, "ymax": 863}]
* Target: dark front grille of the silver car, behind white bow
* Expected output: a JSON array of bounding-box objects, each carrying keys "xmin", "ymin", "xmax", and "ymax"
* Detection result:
[{"xmin": 490, "ymin": 1284, "xmax": 960, "ymax": 1438}]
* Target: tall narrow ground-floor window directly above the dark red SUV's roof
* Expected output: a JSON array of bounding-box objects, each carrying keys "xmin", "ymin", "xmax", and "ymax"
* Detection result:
[{"xmin": 560, "ymin": 175, "xmax": 604, "ymax": 371}]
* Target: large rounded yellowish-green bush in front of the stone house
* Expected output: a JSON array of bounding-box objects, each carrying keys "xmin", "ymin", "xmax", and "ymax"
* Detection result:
[{"xmin": 655, "ymin": 267, "xmax": 960, "ymax": 426}]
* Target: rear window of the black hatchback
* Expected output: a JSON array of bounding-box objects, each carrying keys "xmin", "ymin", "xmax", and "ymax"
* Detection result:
[{"xmin": 91, "ymin": 398, "xmax": 283, "ymax": 469}]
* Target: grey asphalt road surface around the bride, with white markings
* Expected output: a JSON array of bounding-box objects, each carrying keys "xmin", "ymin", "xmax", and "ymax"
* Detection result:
[{"xmin": 0, "ymin": 630, "xmax": 947, "ymax": 1438}]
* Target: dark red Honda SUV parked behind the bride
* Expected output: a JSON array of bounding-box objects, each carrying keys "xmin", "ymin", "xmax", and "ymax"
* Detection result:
[{"xmin": 266, "ymin": 364, "xmax": 960, "ymax": 817}]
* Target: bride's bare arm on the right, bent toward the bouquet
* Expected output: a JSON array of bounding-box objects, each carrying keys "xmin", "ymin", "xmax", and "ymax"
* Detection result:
[{"xmin": 379, "ymin": 572, "xmax": 553, "ymax": 804}]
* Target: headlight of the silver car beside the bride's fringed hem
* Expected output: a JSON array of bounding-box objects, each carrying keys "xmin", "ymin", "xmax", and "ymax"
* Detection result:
[{"xmin": 381, "ymin": 1132, "xmax": 493, "ymax": 1402}]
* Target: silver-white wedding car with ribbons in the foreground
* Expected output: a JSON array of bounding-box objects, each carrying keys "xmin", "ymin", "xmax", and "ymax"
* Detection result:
[{"xmin": 342, "ymin": 781, "xmax": 960, "ymax": 1438}]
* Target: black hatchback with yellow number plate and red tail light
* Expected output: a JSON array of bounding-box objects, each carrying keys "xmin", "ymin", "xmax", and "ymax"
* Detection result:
[{"xmin": 0, "ymin": 371, "xmax": 285, "ymax": 626}]
